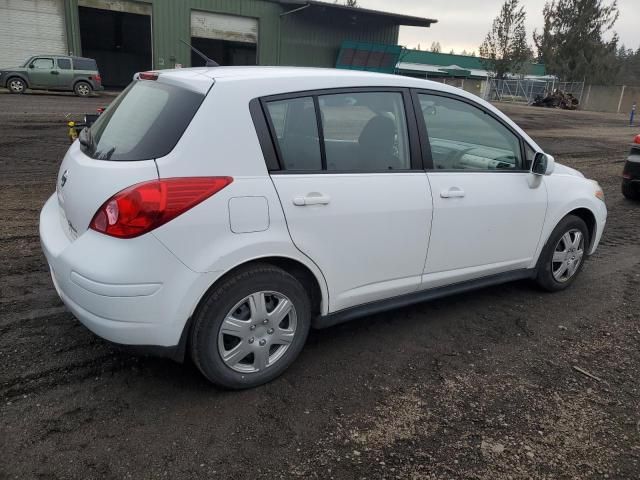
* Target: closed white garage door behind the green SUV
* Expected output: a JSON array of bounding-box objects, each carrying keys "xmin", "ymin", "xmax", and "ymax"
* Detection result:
[{"xmin": 0, "ymin": 0, "xmax": 67, "ymax": 67}]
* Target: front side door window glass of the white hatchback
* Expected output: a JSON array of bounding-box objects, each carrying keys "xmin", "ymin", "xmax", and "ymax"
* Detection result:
[{"xmin": 419, "ymin": 94, "xmax": 523, "ymax": 170}]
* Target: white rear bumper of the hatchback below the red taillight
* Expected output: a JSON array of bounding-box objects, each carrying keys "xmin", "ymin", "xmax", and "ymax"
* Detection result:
[{"xmin": 40, "ymin": 194, "xmax": 220, "ymax": 347}]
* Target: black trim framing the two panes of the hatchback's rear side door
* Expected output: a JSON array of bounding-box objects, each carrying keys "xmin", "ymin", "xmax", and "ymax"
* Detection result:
[{"xmin": 255, "ymin": 86, "xmax": 424, "ymax": 175}]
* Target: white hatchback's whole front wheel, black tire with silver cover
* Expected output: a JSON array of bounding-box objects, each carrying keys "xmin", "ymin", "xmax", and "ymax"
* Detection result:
[{"xmin": 536, "ymin": 215, "xmax": 590, "ymax": 292}]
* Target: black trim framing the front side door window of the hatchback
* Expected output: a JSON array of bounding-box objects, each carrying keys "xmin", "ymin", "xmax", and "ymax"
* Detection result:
[{"xmin": 411, "ymin": 88, "xmax": 529, "ymax": 173}]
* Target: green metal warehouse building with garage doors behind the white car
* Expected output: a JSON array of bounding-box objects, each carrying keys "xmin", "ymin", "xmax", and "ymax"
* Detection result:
[{"xmin": 0, "ymin": 0, "xmax": 436, "ymax": 87}]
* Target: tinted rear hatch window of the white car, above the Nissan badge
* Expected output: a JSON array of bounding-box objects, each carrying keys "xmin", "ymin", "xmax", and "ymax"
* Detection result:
[{"xmin": 80, "ymin": 80, "xmax": 204, "ymax": 161}]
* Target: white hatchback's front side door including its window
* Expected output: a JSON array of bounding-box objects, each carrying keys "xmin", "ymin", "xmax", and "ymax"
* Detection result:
[{"xmin": 414, "ymin": 92, "xmax": 547, "ymax": 288}]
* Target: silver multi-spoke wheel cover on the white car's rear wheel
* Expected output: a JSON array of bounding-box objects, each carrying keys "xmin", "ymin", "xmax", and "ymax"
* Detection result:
[{"xmin": 218, "ymin": 291, "xmax": 297, "ymax": 373}]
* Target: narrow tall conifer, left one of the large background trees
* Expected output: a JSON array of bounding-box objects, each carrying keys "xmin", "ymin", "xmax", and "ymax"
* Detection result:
[{"xmin": 479, "ymin": 0, "xmax": 532, "ymax": 79}]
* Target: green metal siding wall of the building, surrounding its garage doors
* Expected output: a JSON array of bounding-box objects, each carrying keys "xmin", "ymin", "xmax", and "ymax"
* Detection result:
[{"xmin": 65, "ymin": 0, "xmax": 399, "ymax": 68}]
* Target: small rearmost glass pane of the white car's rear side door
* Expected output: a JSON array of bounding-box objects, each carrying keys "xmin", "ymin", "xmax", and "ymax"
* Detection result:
[{"xmin": 267, "ymin": 97, "xmax": 322, "ymax": 170}]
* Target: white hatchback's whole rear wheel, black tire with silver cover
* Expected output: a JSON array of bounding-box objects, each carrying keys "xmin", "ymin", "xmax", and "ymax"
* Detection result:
[{"xmin": 190, "ymin": 264, "xmax": 311, "ymax": 389}]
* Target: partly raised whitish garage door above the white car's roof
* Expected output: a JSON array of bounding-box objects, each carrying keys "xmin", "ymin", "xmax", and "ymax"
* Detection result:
[{"xmin": 191, "ymin": 11, "xmax": 258, "ymax": 43}]
